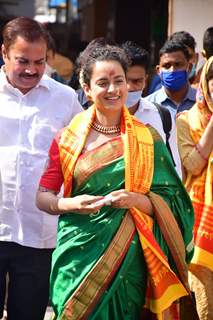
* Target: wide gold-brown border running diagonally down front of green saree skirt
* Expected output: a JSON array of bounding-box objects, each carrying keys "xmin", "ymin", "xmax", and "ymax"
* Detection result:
[{"xmin": 61, "ymin": 212, "xmax": 135, "ymax": 320}]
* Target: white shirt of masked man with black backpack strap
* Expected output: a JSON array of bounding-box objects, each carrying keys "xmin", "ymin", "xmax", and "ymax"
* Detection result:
[{"xmin": 134, "ymin": 98, "xmax": 182, "ymax": 178}]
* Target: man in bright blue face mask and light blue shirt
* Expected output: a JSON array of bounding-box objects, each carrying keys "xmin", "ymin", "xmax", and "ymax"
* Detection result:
[{"xmin": 147, "ymin": 39, "xmax": 196, "ymax": 119}]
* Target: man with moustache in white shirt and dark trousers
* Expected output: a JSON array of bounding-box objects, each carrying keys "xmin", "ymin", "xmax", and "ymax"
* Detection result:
[{"xmin": 0, "ymin": 17, "xmax": 82, "ymax": 320}]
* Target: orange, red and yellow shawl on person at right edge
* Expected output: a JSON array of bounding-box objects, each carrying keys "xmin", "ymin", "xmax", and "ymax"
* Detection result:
[{"xmin": 185, "ymin": 57, "xmax": 213, "ymax": 271}]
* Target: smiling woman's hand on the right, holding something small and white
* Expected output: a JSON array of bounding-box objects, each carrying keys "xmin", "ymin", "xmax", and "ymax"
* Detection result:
[{"xmin": 109, "ymin": 189, "xmax": 152, "ymax": 215}]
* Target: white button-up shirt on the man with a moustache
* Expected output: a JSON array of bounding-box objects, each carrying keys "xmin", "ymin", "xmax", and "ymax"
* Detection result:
[{"xmin": 0, "ymin": 69, "xmax": 82, "ymax": 248}]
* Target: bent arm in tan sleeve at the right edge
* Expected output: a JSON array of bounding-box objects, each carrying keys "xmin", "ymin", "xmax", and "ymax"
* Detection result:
[{"xmin": 177, "ymin": 114, "xmax": 213, "ymax": 175}]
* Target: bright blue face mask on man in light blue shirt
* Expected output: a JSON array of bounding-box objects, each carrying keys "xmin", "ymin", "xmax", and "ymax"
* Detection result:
[{"xmin": 160, "ymin": 70, "xmax": 188, "ymax": 91}]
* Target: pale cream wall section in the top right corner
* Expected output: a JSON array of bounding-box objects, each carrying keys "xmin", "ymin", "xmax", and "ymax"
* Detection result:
[{"xmin": 168, "ymin": 0, "xmax": 213, "ymax": 63}]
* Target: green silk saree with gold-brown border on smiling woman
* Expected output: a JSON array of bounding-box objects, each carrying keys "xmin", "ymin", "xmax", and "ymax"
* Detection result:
[{"xmin": 50, "ymin": 129, "xmax": 193, "ymax": 320}]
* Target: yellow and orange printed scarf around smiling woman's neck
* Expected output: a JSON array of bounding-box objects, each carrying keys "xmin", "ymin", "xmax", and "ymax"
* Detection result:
[{"xmin": 59, "ymin": 106, "xmax": 187, "ymax": 319}]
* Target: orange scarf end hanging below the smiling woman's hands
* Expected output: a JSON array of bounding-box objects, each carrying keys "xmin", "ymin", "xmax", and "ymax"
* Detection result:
[{"xmin": 131, "ymin": 208, "xmax": 188, "ymax": 319}]
